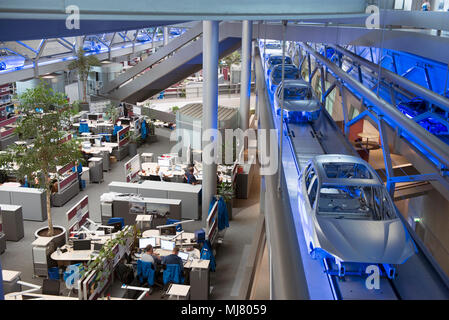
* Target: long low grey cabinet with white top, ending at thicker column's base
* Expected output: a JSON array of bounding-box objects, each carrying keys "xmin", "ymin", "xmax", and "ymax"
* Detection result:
[{"xmin": 109, "ymin": 180, "xmax": 201, "ymax": 220}]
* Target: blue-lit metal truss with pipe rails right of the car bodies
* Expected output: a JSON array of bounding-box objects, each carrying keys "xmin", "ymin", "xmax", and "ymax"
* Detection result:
[{"xmin": 298, "ymin": 43, "xmax": 449, "ymax": 200}]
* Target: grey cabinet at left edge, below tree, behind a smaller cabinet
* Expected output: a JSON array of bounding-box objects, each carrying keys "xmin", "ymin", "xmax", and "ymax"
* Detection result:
[{"xmin": 0, "ymin": 185, "xmax": 47, "ymax": 221}]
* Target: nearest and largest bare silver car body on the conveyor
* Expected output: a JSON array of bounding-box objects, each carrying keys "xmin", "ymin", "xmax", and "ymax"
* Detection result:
[{"xmin": 298, "ymin": 155, "xmax": 416, "ymax": 265}]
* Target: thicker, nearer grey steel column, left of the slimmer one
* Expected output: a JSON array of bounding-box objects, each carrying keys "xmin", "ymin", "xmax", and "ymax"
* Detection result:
[{"xmin": 202, "ymin": 20, "xmax": 218, "ymax": 222}]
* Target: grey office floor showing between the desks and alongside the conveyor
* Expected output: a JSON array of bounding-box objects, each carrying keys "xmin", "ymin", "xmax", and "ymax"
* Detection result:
[{"xmin": 0, "ymin": 129, "xmax": 266, "ymax": 299}]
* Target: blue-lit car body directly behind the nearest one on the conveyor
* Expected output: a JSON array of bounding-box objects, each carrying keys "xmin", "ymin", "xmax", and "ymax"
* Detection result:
[{"xmin": 274, "ymin": 79, "xmax": 321, "ymax": 123}]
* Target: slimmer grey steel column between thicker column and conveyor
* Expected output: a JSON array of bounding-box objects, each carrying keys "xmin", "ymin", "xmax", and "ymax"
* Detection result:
[{"xmin": 239, "ymin": 20, "xmax": 253, "ymax": 131}]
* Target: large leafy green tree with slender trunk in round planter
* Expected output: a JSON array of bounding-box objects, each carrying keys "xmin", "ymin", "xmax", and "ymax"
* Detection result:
[{"xmin": 0, "ymin": 82, "xmax": 81, "ymax": 236}]
